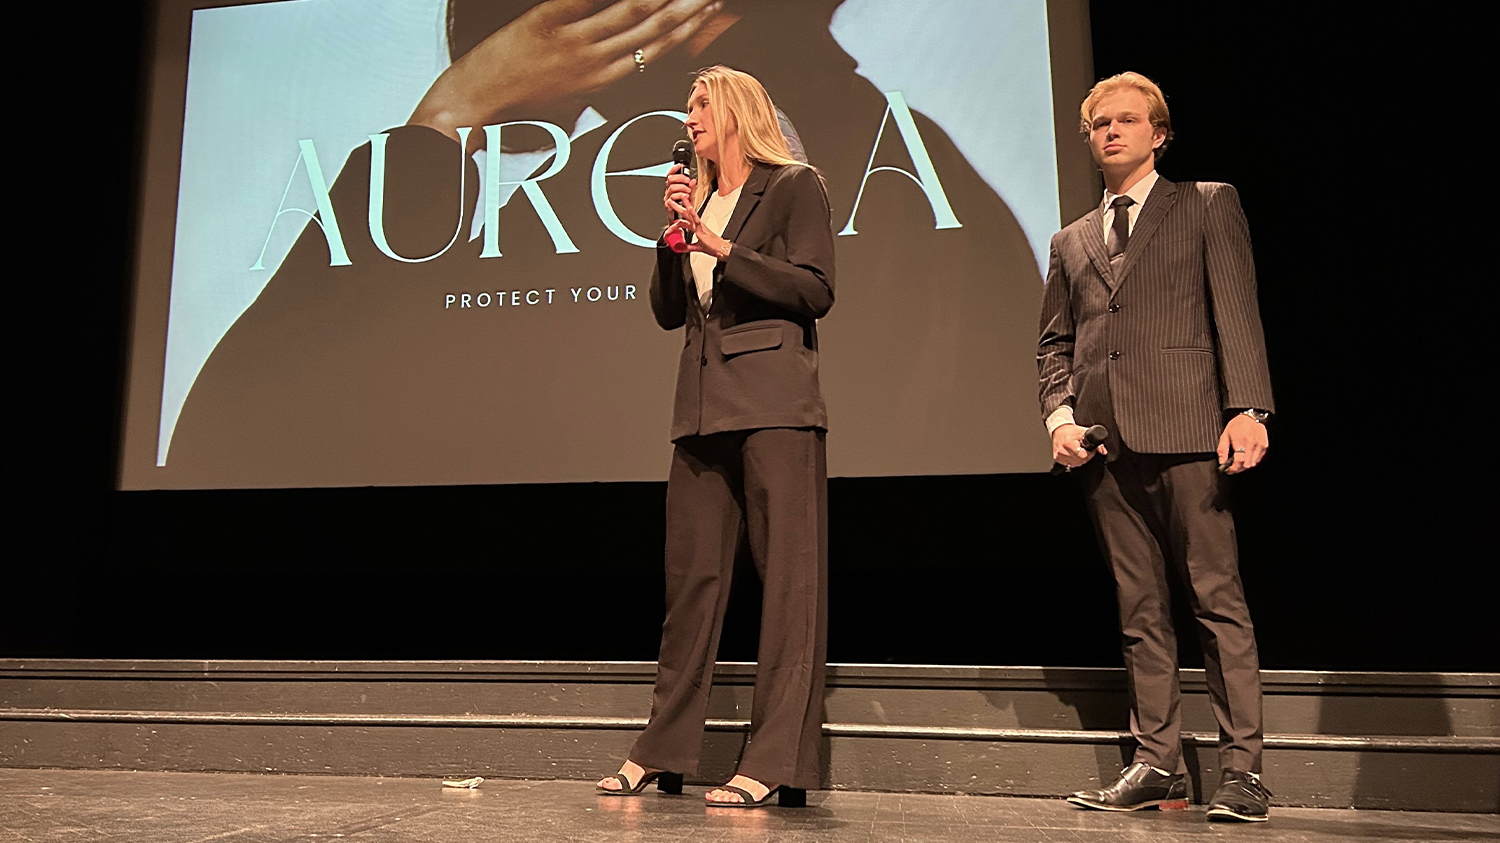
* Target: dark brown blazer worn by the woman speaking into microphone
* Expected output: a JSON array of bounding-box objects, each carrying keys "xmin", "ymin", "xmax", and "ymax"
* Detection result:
[{"xmin": 651, "ymin": 165, "xmax": 834, "ymax": 441}]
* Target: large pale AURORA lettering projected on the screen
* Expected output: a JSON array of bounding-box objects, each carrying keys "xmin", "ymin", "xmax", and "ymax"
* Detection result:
[{"xmin": 251, "ymin": 92, "xmax": 963, "ymax": 268}]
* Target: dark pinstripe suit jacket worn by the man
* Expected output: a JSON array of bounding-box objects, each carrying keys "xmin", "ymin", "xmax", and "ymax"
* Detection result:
[{"xmin": 1037, "ymin": 179, "xmax": 1275, "ymax": 453}]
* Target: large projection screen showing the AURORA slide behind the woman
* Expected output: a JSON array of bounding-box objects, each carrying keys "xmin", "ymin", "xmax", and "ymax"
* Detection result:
[{"xmin": 123, "ymin": 0, "xmax": 1059, "ymax": 488}]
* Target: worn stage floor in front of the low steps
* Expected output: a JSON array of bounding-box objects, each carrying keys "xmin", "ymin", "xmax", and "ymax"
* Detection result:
[{"xmin": 0, "ymin": 770, "xmax": 1500, "ymax": 843}]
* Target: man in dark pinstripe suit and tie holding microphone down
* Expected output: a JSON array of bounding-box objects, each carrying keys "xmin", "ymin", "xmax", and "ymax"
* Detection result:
[{"xmin": 1037, "ymin": 74, "xmax": 1274, "ymax": 822}]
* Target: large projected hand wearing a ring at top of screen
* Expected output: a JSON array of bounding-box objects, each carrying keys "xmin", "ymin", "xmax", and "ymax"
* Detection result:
[{"xmin": 408, "ymin": 0, "xmax": 723, "ymax": 140}]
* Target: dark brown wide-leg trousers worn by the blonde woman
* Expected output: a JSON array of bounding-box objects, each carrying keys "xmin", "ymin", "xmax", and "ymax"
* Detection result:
[{"xmin": 630, "ymin": 428, "xmax": 828, "ymax": 788}]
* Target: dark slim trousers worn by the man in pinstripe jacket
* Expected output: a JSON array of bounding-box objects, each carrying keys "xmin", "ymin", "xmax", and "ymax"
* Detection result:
[{"xmin": 1083, "ymin": 449, "xmax": 1263, "ymax": 773}]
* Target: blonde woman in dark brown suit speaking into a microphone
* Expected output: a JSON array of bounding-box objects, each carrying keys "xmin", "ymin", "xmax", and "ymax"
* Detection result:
[{"xmin": 599, "ymin": 66, "xmax": 834, "ymax": 807}]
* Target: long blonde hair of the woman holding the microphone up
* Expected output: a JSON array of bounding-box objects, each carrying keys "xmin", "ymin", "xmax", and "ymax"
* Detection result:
[{"xmin": 693, "ymin": 65, "xmax": 807, "ymax": 207}]
